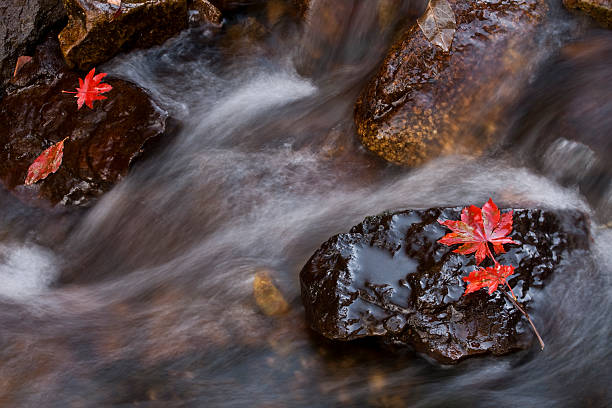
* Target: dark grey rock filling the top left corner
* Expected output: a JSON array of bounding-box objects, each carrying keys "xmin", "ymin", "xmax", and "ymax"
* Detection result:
[{"xmin": 0, "ymin": 0, "xmax": 66, "ymax": 93}]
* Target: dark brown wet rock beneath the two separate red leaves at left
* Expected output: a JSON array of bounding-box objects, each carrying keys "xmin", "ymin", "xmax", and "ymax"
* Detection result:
[{"xmin": 0, "ymin": 37, "xmax": 167, "ymax": 205}]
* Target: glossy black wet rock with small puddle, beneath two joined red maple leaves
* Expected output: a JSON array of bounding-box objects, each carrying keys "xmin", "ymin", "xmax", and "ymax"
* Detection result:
[{"xmin": 300, "ymin": 208, "xmax": 589, "ymax": 363}]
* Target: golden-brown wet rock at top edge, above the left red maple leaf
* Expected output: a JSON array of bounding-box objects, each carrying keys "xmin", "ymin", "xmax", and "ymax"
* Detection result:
[{"xmin": 59, "ymin": 0, "xmax": 188, "ymax": 70}]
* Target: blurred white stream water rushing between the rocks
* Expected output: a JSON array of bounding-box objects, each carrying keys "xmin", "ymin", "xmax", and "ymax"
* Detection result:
[{"xmin": 0, "ymin": 0, "xmax": 612, "ymax": 408}]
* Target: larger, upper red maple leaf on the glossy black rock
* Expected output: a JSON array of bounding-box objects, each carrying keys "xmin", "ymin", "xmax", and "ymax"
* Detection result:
[{"xmin": 438, "ymin": 198, "xmax": 516, "ymax": 265}]
